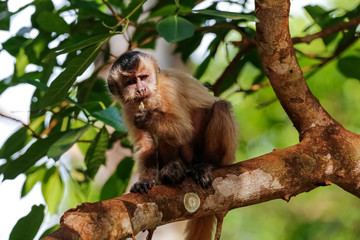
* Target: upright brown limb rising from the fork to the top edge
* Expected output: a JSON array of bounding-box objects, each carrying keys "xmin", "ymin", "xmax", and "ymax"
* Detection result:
[{"xmin": 256, "ymin": 0, "xmax": 338, "ymax": 138}]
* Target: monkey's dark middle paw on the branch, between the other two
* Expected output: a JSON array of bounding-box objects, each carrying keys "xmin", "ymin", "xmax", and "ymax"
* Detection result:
[{"xmin": 160, "ymin": 161, "xmax": 186, "ymax": 184}]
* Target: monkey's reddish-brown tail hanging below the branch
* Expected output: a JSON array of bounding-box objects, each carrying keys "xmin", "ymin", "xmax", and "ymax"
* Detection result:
[{"xmin": 185, "ymin": 215, "xmax": 216, "ymax": 240}]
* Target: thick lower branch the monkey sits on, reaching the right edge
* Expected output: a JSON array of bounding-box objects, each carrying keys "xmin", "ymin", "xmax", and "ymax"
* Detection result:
[{"xmin": 41, "ymin": 125, "xmax": 360, "ymax": 240}]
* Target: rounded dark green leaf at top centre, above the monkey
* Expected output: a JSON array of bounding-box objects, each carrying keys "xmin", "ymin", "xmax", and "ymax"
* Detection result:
[{"xmin": 156, "ymin": 15, "xmax": 195, "ymax": 42}]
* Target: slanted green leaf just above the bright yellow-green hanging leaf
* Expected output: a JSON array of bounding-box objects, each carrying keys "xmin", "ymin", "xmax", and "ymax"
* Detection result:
[{"xmin": 47, "ymin": 126, "xmax": 88, "ymax": 159}]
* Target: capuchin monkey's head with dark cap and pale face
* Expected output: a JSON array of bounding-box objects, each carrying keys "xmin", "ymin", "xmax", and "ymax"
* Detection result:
[{"xmin": 107, "ymin": 51, "xmax": 159, "ymax": 103}]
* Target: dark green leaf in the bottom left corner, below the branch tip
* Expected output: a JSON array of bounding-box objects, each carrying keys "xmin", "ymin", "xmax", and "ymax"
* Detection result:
[{"xmin": 9, "ymin": 205, "xmax": 45, "ymax": 240}]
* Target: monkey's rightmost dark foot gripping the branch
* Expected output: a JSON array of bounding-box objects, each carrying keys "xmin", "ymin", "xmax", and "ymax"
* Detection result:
[{"xmin": 188, "ymin": 163, "xmax": 214, "ymax": 188}]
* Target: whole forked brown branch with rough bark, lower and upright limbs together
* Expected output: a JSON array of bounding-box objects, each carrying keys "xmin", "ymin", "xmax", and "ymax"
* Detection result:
[{"xmin": 45, "ymin": 0, "xmax": 360, "ymax": 240}]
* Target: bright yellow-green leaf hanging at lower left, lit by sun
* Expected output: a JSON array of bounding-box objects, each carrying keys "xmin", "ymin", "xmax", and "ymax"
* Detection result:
[{"xmin": 41, "ymin": 167, "xmax": 64, "ymax": 214}]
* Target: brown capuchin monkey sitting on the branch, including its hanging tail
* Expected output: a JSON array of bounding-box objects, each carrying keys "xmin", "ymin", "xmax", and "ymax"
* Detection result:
[{"xmin": 108, "ymin": 51, "xmax": 237, "ymax": 240}]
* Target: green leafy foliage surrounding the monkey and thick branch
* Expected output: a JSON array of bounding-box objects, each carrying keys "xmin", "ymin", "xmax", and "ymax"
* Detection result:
[{"xmin": 0, "ymin": 0, "xmax": 360, "ymax": 240}]
